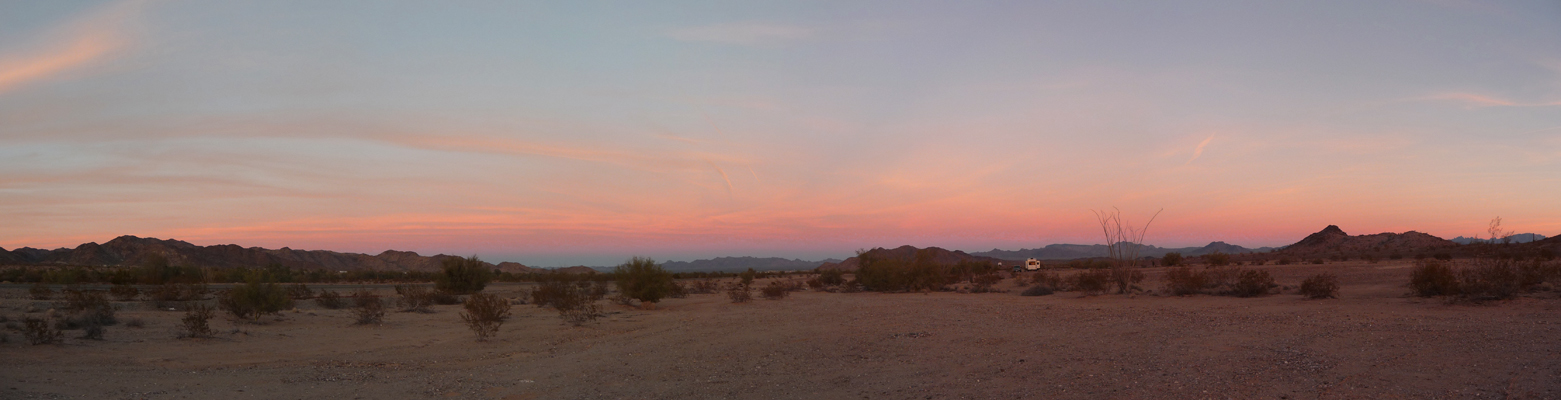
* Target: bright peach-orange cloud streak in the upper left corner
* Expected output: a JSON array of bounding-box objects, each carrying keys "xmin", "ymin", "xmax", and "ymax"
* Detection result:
[{"xmin": 0, "ymin": 2, "xmax": 140, "ymax": 92}]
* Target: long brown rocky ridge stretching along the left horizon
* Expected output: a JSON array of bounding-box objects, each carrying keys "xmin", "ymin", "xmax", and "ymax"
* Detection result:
[{"xmin": 0, "ymin": 236, "xmax": 539, "ymax": 273}]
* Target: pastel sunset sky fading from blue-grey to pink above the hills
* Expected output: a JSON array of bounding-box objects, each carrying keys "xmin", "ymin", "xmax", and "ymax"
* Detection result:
[{"xmin": 0, "ymin": 0, "xmax": 1561, "ymax": 267}]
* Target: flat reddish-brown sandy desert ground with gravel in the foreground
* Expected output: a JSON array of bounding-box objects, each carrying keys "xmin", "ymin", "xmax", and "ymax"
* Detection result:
[{"xmin": 0, "ymin": 263, "xmax": 1561, "ymax": 398}]
